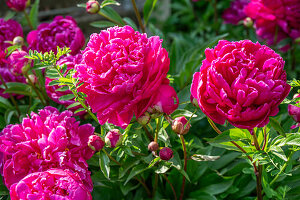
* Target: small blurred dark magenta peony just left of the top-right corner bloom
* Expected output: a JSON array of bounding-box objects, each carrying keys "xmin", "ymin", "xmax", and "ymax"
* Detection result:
[{"xmin": 222, "ymin": 0, "xmax": 250, "ymax": 25}]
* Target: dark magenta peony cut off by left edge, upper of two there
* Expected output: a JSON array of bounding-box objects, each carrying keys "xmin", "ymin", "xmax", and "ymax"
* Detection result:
[{"xmin": 0, "ymin": 18, "xmax": 23, "ymax": 50}]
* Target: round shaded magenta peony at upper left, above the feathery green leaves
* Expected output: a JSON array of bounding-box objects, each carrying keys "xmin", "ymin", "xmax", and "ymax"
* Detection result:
[{"xmin": 27, "ymin": 16, "xmax": 85, "ymax": 55}]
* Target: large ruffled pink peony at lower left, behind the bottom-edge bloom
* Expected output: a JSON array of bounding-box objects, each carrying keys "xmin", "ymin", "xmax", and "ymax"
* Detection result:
[{"xmin": 0, "ymin": 107, "xmax": 94, "ymax": 191}]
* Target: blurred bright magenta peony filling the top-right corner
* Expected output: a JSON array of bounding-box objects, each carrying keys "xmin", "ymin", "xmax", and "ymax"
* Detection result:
[{"xmin": 245, "ymin": 0, "xmax": 300, "ymax": 50}]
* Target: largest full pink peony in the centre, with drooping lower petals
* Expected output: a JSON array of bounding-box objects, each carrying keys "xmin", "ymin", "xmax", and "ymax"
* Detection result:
[{"xmin": 76, "ymin": 26, "xmax": 177, "ymax": 128}]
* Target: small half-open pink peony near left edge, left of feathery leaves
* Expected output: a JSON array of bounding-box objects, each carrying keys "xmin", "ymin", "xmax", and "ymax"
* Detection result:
[{"xmin": 8, "ymin": 50, "xmax": 31, "ymax": 74}]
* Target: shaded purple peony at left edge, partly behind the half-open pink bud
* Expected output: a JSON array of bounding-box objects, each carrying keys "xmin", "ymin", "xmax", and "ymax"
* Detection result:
[{"xmin": 0, "ymin": 49, "xmax": 26, "ymax": 99}]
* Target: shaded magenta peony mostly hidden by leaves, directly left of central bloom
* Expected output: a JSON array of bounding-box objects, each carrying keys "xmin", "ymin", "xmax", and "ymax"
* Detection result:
[{"xmin": 45, "ymin": 54, "xmax": 86, "ymax": 115}]
